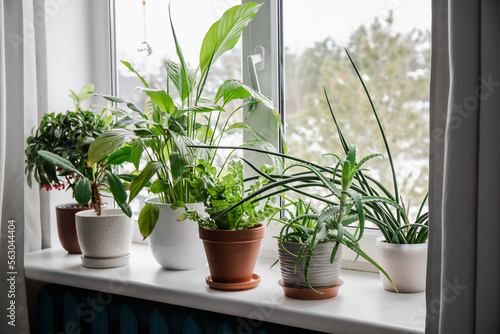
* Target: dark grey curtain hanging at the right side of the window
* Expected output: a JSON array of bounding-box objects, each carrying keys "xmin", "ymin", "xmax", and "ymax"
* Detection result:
[{"xmin": 426, "ymin": 0, "xmax": 500, "ymax": 334}]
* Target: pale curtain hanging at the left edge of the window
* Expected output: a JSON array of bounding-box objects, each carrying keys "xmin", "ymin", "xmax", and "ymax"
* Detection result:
[{"xmin": 0, "ymin": 1, "xmax": 29, "ymax": 333}]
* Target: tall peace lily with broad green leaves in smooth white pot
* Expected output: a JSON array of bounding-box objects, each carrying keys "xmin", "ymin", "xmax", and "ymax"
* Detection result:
[{"xmin": 89, "ymin": 3, "xmax": 274, "ymax": 270}]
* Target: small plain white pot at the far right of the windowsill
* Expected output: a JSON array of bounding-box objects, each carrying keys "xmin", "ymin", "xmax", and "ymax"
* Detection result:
[{"xmin": 377, "ymin": 236, "xmax": 427, "ymax": 293}]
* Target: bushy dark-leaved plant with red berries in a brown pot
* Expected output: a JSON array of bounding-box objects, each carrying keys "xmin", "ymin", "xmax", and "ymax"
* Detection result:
[{"xmin": 25, "ymin": 84, "xmax": 111, "ymax": 254}]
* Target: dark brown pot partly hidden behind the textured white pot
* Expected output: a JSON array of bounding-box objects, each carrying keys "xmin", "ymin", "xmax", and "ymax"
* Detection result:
[{"xmin": 56, "ymin": 203, "xmax": 91, "ymax": 254}]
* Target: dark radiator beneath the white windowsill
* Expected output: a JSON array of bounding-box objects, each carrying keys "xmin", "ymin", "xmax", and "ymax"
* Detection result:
[{"xmin": 38, "ymin": 284, "xmax": 318, "ymax": 334}]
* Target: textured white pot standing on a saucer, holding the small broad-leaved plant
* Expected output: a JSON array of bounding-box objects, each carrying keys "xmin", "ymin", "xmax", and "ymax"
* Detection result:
[{"xmin": 75, "ymin": 209, "xmax": 134, "ymax": 259}]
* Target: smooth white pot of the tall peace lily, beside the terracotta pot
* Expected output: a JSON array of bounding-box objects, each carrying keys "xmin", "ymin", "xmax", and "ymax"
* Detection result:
[{"xmin": 146, "ymin": 197, "xmax": 207, "ymax": 270}]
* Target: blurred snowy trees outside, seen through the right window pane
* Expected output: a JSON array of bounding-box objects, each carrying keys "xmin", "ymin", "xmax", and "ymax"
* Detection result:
[{"xmin": 285, "ymin": 16, "xmax": 430, "ymax": 207}]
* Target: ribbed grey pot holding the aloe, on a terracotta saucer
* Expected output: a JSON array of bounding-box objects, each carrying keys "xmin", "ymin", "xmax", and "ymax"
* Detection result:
[{"xmin": 278, "ymin": 241, "xmax": 342, "ymax": 289}]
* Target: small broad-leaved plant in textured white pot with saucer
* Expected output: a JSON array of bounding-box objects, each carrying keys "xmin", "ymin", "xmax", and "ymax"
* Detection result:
[{"xmin": 38, "ymin": 145, "xmax": 133, "ymax": 268}]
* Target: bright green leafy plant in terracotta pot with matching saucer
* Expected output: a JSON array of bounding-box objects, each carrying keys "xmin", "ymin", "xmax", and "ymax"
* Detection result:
[{"xmin": 175, "ymin": 160, "xmax": 279, "ymax": 290}]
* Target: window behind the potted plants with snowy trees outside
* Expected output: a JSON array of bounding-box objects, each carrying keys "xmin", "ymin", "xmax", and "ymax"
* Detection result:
[{"xmin": 111, "ymin": 0, "xmax": 431, "ymax": 266}]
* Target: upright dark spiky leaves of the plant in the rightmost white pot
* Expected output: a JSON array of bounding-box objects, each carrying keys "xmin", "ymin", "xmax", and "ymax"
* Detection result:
[{"xmin": 325, "ymin": 49, "xmax": 429, "ymax": 244}]
